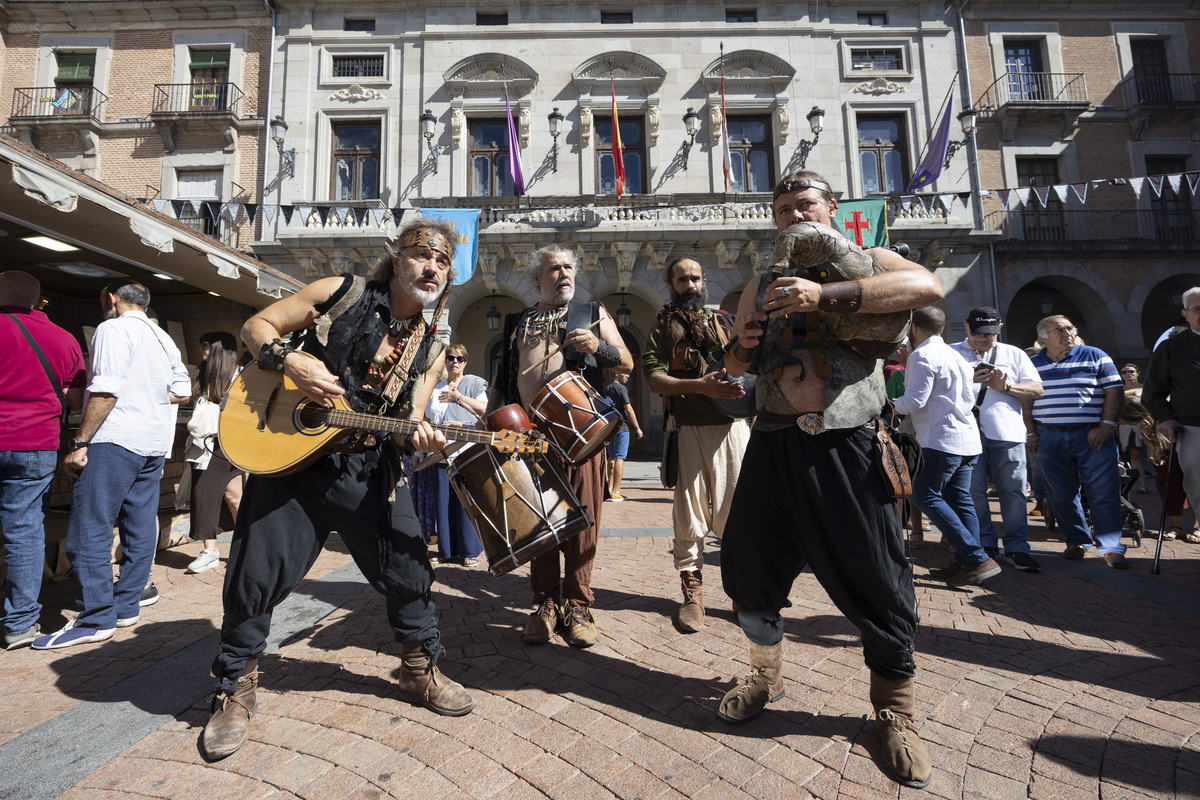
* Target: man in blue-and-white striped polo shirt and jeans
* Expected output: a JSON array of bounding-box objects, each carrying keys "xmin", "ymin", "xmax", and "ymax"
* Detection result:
[{"xmin": 1022, "ymin": 315, "xmax": 1129, "ymax": 570}]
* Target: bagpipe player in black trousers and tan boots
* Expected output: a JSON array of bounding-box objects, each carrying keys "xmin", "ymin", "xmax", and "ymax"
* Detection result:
[{"xmin": 719, "ymin": 172, "xmax": 942, "ymax": 787}]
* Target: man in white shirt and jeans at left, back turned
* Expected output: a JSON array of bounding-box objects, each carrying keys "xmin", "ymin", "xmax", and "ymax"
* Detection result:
[{"xmin": 32, "ymin": 279, "xmax": 192, "ymax": 650}]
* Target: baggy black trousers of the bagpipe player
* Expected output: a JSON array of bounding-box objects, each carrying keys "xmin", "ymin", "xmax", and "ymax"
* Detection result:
[{"xmin": 721, "ymin": 427, "xmax": 917, "ymax": 680}]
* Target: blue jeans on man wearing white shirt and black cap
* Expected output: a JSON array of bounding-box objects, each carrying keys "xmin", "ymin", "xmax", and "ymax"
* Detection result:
[{"xmin": 971, "ymin": 434, "xmax": 1030, "ymax": 553}]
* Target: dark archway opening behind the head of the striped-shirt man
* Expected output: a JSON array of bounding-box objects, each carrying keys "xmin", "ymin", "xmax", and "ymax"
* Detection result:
[{"xmin": 1000, "ymin": 260, "xmax": 1130, "ymax": 359}]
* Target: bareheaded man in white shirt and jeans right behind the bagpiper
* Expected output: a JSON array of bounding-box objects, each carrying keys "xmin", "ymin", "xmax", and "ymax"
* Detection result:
[{"xmin": 895, "ymin": 306, "xmax": 1000, "ymax": 587}]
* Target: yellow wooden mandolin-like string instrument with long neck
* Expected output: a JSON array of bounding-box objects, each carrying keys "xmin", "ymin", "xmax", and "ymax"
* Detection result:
[{"xmin": 217, "ymin": 354, "xmax": 548, "ymax": 475}]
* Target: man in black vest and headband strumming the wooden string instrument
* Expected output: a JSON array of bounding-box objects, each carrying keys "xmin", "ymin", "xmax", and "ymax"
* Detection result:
[{"xmin": 200, "ymin": 219, "xmax": 475, "ymax": 759}]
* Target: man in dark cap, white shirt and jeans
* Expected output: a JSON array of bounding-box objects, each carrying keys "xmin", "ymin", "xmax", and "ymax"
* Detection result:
[{"xmin": 950, "ymin": 306, "xmax": 1042, "ymax": 572}]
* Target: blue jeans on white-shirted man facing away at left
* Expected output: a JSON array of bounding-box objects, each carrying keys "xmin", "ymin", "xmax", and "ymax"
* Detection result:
[{"xmin": 67, "ymin": 441, "xmax": 164, "ymax": 630}]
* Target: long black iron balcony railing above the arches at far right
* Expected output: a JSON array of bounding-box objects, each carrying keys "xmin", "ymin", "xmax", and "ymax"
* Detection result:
[{"xmin": 985, "ymin": 208, "xmax": 1200, "ymax": 242}]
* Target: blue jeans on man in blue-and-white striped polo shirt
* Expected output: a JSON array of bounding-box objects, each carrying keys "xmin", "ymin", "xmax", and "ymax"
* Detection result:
[{"xmin": 1037, "ymin": 425, "xmax": 1126, "ymax": 554}]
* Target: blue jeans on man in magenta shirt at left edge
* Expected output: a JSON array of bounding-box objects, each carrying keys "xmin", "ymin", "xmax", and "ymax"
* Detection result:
[{"xmin": 0, "ymin": 450, "xmax": 58, "ymax": 633}]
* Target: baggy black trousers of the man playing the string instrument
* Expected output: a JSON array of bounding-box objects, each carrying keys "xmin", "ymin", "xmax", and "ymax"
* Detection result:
[{"xmin": 212, "ymin": 453, "xmax": 443, "ymax": 691}]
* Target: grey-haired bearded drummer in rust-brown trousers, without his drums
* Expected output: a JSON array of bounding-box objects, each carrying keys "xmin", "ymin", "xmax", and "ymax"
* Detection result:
[{"xmin": 488, "ymin": 245, "xmax": 634, "ymax": 648}]
